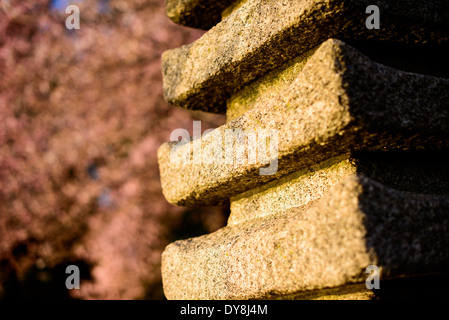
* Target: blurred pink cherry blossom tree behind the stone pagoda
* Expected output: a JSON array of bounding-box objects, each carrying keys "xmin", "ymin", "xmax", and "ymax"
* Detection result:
[{"xmin": 0, "ymin": 0, "xmax": 226, "ymax": 299}]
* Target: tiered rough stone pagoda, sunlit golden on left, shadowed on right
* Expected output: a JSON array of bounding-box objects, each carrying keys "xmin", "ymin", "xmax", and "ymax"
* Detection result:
[{"xmin": 158, "ymin": 0, "xmax": 449, "ymax": 299}]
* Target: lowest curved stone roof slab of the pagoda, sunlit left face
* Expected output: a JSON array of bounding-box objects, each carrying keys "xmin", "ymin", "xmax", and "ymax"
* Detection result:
[{"xmin": 162, "ymin": 175, "xmax": 449, "ymax": 299}]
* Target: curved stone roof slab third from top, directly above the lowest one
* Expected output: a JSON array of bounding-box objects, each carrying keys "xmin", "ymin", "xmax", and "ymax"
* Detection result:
[{"xmin": 158, "ymin": 39, "xmax": 449, "ymax": 206}]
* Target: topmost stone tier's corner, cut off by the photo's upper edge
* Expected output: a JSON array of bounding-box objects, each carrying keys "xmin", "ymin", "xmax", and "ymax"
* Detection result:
[{"xmin": 166, "ymin": 0, "xmax": 235, "ymax": 30}]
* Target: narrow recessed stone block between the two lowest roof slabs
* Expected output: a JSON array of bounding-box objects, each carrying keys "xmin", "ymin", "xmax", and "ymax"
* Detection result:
[{"xmin": 228, "ymin": 152, "xmax": 449, "ymax": 225}]
